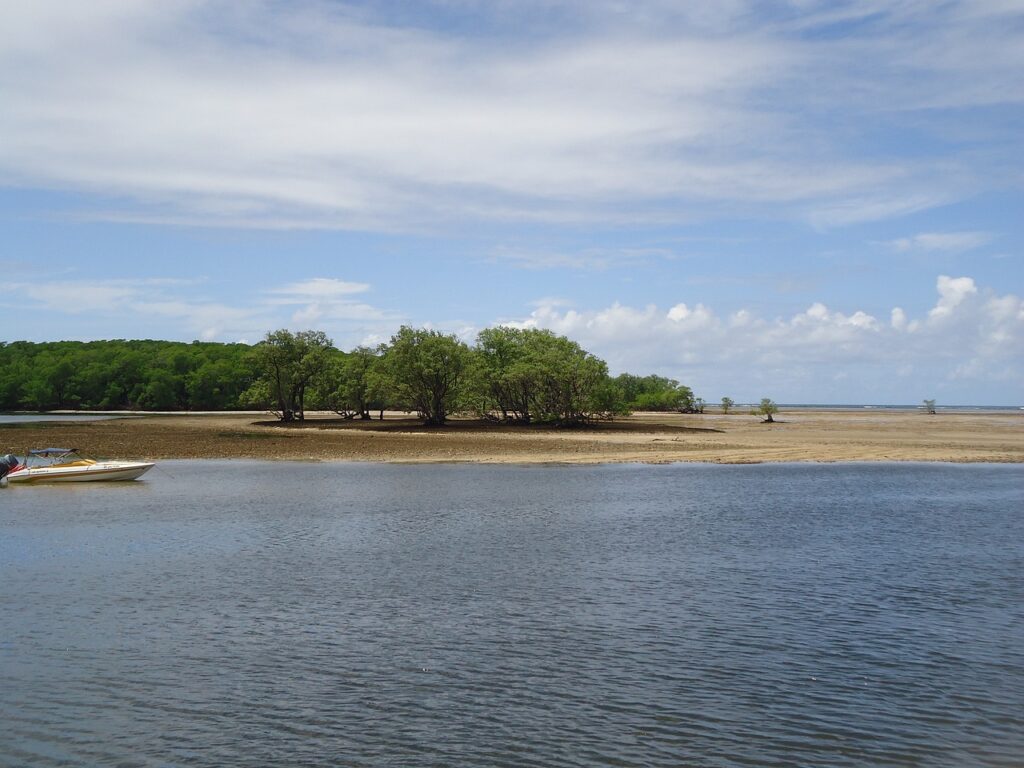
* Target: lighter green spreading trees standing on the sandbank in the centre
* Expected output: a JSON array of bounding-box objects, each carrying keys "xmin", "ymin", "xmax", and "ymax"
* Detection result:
[{"xmin": 244, "ymin": 327, "xmax": 693, "ymax": 425}]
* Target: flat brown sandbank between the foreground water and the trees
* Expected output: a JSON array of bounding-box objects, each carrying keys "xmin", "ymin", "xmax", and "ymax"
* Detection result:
[{"xmin": 0, "ymin": 410, "xmax": 1024, "ymax": 464}]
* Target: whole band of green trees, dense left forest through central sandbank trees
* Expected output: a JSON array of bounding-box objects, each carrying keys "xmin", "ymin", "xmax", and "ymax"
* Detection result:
[{"xmin": 0, "ymin": 327, "xmax": 703, "ymax": 425}]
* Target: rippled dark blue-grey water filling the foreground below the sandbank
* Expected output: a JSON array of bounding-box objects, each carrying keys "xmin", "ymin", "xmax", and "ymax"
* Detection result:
[{"xmin": 0, "ymin": 462, "xmax": 1024, "ymax": 766}]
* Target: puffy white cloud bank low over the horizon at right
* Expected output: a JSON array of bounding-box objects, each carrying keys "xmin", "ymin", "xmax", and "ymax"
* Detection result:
[{"xmin": 507, "ymin": 275, "xmax": 1024, "ymax": 402}]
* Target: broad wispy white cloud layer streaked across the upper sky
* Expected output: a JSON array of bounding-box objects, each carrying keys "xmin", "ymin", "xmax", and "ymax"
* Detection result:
[{"xmin": 0, "ymin": 0, "xmax": 1024, "ymax": 230}]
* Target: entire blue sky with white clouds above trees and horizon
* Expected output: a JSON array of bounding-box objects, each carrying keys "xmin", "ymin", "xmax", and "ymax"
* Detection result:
[{"xmin": 0, "ymin": 0, "xmax": 1024, "ymax": 406}]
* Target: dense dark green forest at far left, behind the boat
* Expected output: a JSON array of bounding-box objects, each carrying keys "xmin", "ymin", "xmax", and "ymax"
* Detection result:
[{"xmin": 0, "ymin": 341, "xmax": 258, "ymax": 411}]
